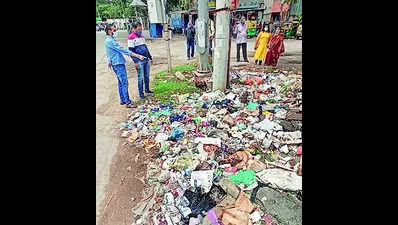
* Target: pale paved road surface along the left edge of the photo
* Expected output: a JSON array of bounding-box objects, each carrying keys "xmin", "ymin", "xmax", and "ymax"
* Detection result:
[{"xmin": 96, "ymin": 32, "xmax": 127, "ymax": 223}]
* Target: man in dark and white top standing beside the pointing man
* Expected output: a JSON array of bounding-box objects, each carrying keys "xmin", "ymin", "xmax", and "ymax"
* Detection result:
[{"xmin": 128, "ymin": 22, "xmax": 153, "ymax": 99}]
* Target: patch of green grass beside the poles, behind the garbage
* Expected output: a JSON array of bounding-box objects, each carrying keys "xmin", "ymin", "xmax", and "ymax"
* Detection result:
[{"xmin": 153, "ymin": 64, "xmax": 198, "ymax": 103}]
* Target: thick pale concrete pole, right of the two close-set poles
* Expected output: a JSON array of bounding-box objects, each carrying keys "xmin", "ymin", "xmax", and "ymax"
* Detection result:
[{"xmin": 213, "ymin": 0, "xmax": 231, "ymax": 91}]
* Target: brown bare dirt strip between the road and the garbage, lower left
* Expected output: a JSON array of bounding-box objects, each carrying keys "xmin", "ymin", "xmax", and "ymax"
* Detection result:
[{"xmin": 98, "ymin": 139, "xmax": 156, "ymax": 225}]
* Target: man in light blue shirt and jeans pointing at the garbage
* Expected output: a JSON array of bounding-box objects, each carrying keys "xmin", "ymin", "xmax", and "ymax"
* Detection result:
[{"xmin": 105, "ymin": 24, "xmax": 145, "ymax": 108}]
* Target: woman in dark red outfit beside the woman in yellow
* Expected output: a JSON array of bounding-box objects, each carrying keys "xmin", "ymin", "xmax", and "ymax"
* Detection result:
[{"xmin": 264, "ymin": 27, "xmax": 285, "ymax": 66}]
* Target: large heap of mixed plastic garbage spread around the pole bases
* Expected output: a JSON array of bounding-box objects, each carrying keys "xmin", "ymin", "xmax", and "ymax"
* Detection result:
[{"xmin": 121, "ymin": 72, "xmax": 302, "ymax": 225}]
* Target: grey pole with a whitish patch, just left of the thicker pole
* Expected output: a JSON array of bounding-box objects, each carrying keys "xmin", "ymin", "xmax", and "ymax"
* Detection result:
[{"xmin": 196, "ymin": 0, "xmax": 209, "ymax": 72}]
